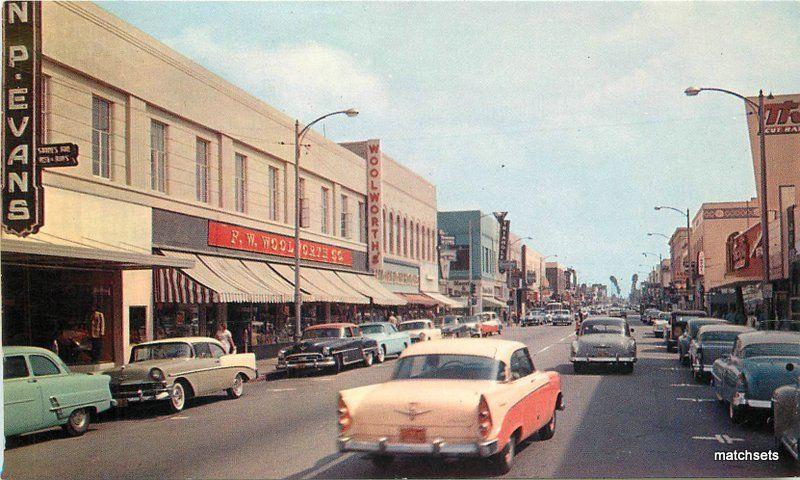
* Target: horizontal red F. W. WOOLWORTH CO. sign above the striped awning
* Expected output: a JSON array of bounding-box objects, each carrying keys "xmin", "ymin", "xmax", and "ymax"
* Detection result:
[{"xmin": 208, "ymin": 220, "xmax": 353, "ymax": 267}]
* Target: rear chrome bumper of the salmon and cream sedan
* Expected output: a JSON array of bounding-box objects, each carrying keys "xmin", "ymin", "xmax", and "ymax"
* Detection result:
[{"xmin": 336, "ymin": 437, "xmax": 498, "ymax": 457}]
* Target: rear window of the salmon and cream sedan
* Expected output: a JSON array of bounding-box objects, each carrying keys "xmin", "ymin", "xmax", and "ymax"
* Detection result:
[{"xmin": 392, "ymin": 354, "xmax": 505, "ymax": 380}]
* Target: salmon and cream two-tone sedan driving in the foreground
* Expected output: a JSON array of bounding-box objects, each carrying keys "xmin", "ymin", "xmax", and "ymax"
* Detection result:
[{"xmin": 338, "ymin": 339, "xmax": 564, "ymax": 473}]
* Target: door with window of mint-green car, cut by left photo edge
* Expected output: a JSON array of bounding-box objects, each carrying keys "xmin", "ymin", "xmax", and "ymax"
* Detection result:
[{"xmin": 3, "ymin": 355, "xmax": 43, "ymax": 436}]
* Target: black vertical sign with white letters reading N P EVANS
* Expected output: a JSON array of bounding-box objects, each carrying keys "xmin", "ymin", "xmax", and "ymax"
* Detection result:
[{"xmin": 2, "ymin": 1, "xmax": 44, "ymax": 237}]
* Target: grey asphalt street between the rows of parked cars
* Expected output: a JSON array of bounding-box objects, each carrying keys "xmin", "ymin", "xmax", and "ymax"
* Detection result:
[{"xmin": 3, "ymin": 325, "xmax": 800, "ymax": 479}]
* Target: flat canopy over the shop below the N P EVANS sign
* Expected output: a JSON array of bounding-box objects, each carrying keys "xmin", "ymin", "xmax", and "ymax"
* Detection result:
[{"xmin": 0, "ymin": 238, "xmax": 193, "ymax": 270}]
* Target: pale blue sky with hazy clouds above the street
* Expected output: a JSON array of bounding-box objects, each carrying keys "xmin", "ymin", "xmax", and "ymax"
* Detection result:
[{"xmin": 100, "ymin": 2, "xmax": 800, "ymax": 293}]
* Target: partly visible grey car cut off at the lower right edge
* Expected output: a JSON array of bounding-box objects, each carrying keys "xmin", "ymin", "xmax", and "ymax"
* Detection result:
[{"xmin": 772, "ymin": 362, "xmax": 800, "ymax": 463}]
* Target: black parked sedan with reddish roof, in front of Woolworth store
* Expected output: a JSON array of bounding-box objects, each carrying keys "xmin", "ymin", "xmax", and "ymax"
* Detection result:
[{"xmin": 276, "ymin": 323, "xmax": 380, "ymax": 374}]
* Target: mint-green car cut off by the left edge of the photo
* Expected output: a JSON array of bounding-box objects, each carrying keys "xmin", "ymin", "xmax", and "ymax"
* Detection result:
[{"xmin": 3, "ymin": 347, "xmax": 114, "ymax": 437}]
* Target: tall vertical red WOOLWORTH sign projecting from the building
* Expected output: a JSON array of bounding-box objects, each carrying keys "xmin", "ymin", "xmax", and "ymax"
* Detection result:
[{"xmin": 366, "ymin": 140, "xmax": 383, "ymax": 272}]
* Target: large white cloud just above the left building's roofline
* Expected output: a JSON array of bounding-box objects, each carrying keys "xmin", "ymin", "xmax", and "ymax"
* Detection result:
[{"xmin": 165, "ymin": 27, "xmax": 390, "ymax": 118}]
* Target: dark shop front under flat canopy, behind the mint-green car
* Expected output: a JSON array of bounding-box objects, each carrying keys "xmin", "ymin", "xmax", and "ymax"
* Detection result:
[{"xmin": 2, "ymin": 265, "xmax": 121, "ymax": 365}]
